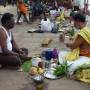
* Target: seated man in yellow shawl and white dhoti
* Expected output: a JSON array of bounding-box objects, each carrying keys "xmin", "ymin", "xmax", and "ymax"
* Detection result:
[{"xmin": 59, "ymin": 13, "xmax": 90, "ymax": 75}]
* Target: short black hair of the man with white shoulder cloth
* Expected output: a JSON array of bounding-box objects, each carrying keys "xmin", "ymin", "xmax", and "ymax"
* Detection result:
[{"xmin": 1, "ymin": 13, "xmax": 14, "ymax": 25}]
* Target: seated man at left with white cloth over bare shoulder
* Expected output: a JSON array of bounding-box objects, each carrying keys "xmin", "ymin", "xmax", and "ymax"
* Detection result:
[{"xmin": 0, "ymin": 13, "xmax": 28, "ymax": 67}]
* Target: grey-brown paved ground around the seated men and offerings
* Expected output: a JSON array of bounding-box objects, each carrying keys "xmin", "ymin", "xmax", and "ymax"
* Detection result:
[{"xmin": 0, "ymin": 6, "xmax": 90, "ymax": 90}]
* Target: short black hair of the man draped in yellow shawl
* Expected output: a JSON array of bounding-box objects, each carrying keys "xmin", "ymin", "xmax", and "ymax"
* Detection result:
[{"xmin": 73, "ymin": 12, "xmax": 86, "ymax": 22}]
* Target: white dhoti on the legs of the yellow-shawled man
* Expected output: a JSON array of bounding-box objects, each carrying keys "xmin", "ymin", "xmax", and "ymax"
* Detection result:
[{"xmin": 59, "ymin": 51, "xmax": 90, "ymax": 75}]
